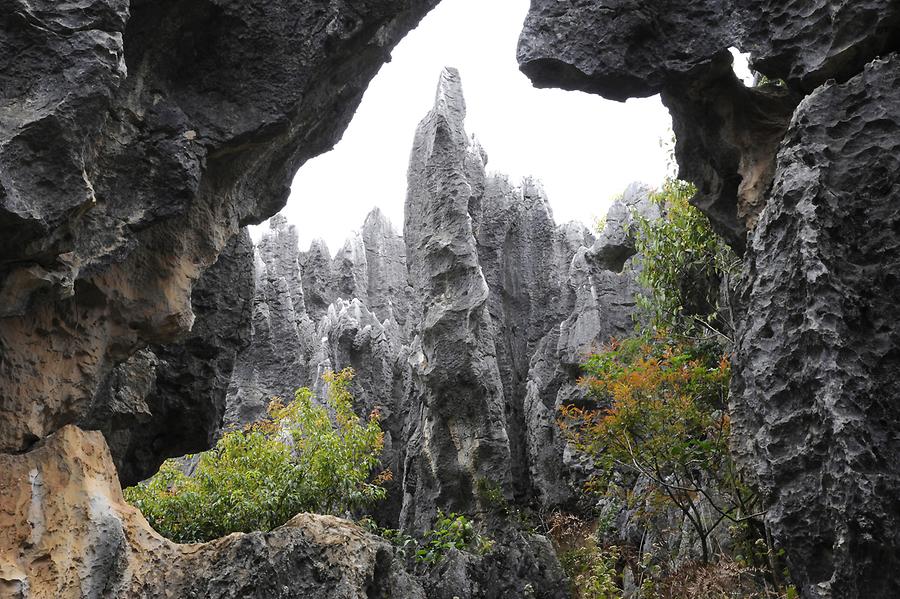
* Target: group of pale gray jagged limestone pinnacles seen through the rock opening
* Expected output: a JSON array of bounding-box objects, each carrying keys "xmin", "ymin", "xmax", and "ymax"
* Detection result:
[{"xmin": 228, "ymin": 69, "xmax": 658, "ymax": 530}]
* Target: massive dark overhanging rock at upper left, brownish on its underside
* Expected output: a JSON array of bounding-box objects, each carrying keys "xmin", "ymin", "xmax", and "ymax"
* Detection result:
[{"xmin": 0, "ymin": 0, "xmax": 436, "ymax": 451}]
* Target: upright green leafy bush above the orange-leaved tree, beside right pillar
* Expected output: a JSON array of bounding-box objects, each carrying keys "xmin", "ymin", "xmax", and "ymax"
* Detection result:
[{"xmin": 634, "ymin": 178, "xmax": 739, "ymax": 337}]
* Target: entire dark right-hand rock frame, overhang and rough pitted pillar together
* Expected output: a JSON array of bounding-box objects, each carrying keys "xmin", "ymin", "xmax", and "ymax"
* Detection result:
[{"xmin": 519, "ymin": 0, "xmax": 900, "ymax": 599}]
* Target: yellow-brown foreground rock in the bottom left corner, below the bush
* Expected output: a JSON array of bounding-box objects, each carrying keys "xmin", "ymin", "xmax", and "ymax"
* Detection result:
[{"xmin": 0, "ymin": 426, "xmax": 424, "ymax": 599}]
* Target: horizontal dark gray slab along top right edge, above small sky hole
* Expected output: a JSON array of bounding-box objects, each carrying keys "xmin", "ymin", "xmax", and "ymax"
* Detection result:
[{"xmin": 518, "ymin": 0, "xmax": 900, "ymax": 100}]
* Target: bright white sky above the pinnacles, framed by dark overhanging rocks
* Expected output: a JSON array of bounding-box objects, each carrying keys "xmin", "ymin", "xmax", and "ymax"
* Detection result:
[{"xmin": 253, "ymin": 0, "xmax": 752, "ymax": 253}]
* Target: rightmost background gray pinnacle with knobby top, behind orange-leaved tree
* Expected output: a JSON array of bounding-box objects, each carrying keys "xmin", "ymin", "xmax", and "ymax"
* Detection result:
[{"xmin": 523, "ymin": 190, "xmax": 659, "ymax": 505}]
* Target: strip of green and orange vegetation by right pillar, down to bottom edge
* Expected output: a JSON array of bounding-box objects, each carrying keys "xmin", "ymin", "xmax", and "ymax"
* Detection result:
[{"xmin": 557, "ymin": 179, "xmax": 796, "ymax": 599}]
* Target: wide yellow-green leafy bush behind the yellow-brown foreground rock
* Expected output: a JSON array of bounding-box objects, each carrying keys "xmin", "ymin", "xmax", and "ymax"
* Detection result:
[{"xmin": 125, "ymin": 369, "xmax": 390, "ymax": 542}]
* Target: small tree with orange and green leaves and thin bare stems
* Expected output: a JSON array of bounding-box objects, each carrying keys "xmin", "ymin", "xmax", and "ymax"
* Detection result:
[{"xmin": 560, "ymin": 336, "xmax": 760, "ymax": 562}]
